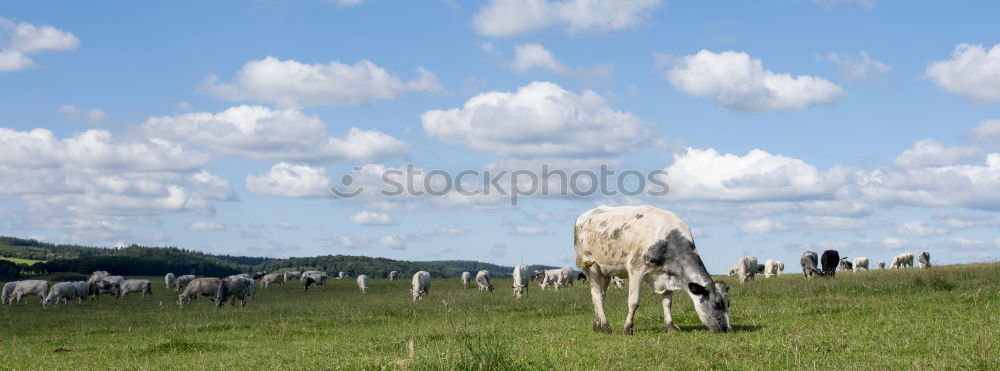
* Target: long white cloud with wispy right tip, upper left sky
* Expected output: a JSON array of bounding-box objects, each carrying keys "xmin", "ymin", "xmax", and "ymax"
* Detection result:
[{"xmin": 201, "ymin": 56, "xmax": 442, "ymax": 107}]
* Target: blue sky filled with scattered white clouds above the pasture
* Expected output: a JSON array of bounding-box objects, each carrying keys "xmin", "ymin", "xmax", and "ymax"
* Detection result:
[{"xmin": 0, "ymin": 0, "xmax": 1000, "ymax": 273}]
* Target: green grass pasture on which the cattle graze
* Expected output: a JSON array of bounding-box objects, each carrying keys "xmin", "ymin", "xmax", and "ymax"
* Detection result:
[{"xmin": 0, "ymin": 264, "xmax": 1000, "ymax": 370}]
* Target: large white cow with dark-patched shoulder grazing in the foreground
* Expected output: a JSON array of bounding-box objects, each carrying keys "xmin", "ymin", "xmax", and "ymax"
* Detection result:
[{"xmin": 573, "ymin": 206, "xmax": 732, "ymax": 334}]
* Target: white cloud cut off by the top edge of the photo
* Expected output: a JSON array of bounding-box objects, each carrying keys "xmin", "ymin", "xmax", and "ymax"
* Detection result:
[{"xmin": 473, "ymin": 0, "xmax": 662, "ymax": 37}]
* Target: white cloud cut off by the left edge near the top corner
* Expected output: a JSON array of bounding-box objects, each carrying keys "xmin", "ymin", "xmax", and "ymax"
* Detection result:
[{"xmin": 0, "ymin": 17, "xmax": 80, "ymax": 72}]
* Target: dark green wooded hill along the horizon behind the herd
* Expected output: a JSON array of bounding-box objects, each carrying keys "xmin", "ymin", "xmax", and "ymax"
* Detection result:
[{"xmin": 0, "ymin": 237, "xmax": 555, "ymax": 279}]
